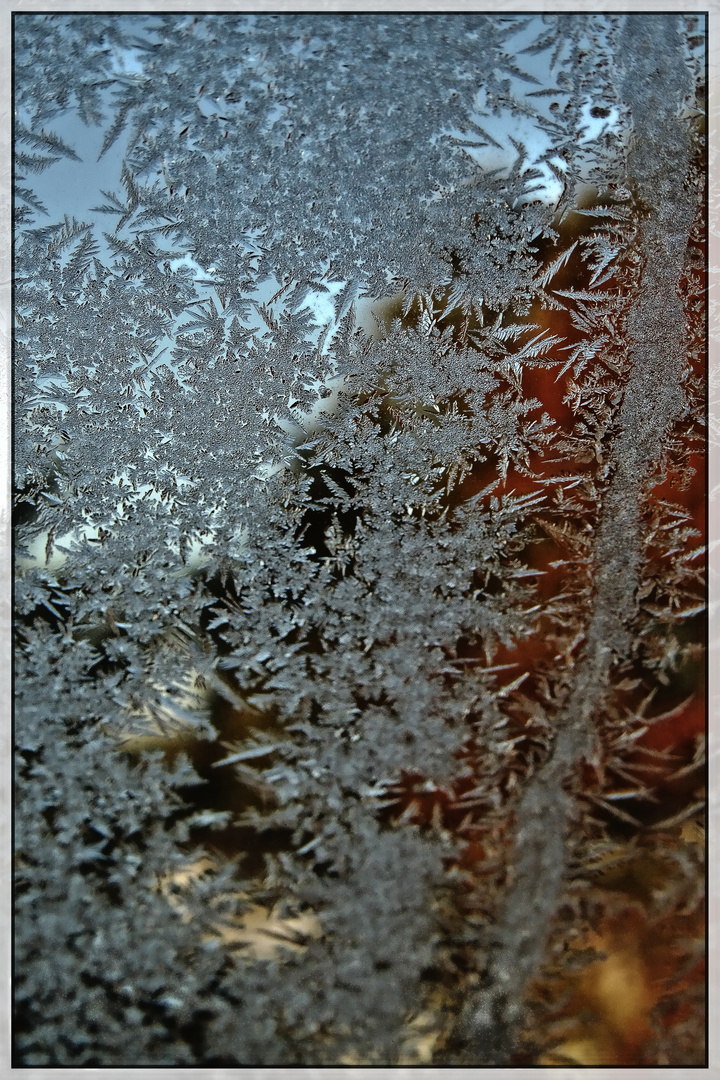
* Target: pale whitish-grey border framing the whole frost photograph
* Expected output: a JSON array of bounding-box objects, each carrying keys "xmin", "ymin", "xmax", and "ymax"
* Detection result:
[{"xmin": 0, "ymin": 0, "xmax": 720, "ymax": 1080}]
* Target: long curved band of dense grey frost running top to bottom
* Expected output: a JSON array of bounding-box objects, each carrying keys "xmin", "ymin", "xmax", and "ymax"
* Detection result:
[{"xmin": 457, "ymin": 15, "xmax": 694, "ymax": 1066}]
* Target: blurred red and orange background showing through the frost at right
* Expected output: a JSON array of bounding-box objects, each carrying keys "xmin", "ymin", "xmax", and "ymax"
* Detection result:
[{"xmin": 384, "ymin": 185, "xmax": 707, "ymax": 1067}]
